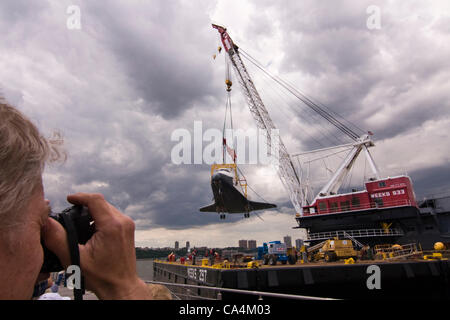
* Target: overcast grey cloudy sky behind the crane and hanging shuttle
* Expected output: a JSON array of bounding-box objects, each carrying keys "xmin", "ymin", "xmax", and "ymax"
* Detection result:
[{"xmin": 0, "ymin": 0, "xmax": 450, "ymax": 247}]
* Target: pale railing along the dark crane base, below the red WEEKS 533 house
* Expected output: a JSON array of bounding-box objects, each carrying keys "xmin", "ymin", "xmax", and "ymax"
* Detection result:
[{"xmin": 307, "ymin": 228, "xmax": 404, "ymax": 240}]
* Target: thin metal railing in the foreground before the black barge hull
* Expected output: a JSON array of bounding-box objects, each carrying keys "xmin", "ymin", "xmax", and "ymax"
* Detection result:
[{"xmin": 145, "ymin": 280, "xmax": 339, "ymax": 301}]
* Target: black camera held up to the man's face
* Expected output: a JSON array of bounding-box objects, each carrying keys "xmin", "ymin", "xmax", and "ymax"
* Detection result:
[{"xmin": 41, "ymin": 205, "xmax": 95, "ymax": 273}]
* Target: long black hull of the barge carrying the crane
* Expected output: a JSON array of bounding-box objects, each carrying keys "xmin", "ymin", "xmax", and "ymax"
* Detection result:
[{"xmin": 154, "ymin": 260, "xmax": 450, "ymax": 300}]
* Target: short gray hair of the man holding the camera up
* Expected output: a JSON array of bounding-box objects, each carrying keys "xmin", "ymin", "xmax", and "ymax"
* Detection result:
[{"xmin": 0, "ymin": 97, "xmax": 65, "ymax": 227}]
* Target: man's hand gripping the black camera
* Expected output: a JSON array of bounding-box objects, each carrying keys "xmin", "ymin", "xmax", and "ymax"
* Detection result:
[{"xmin": 44, "ymin": 193, "xmax": 152, "ymax": 299}]
